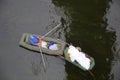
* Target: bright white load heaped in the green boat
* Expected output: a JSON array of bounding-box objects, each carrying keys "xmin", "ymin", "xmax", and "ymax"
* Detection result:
[{"xmin": 67, "ymin": 45, "xmax": 91, "ymax": 69}]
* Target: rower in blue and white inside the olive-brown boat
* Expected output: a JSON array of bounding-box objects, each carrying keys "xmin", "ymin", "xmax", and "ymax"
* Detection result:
[{"xmin": 29, "ymin": 35, "xmax": 59, "ymax": 50}]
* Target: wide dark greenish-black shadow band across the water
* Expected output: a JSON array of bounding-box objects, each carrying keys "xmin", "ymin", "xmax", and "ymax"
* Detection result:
[{"xmin": 52, "ymin": 0, "xmax": 116, "ymax": 80}]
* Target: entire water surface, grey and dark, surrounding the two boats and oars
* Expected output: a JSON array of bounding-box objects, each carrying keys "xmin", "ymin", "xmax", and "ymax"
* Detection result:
[{"xmin": 0, "ymin": 0, "xmax": 120, "ymax": 80}]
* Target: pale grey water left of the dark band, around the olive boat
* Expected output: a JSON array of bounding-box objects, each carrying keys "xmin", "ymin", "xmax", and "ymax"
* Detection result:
[{"xmin": 0, "ymin": 0, "xmax": 66, "ymax": 80}]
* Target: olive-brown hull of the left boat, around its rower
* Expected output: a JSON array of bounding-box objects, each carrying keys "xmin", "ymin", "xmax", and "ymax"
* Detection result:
[{"xmin": 19, "ymin": 33, "xmax": 66, "ymax": 55}]
